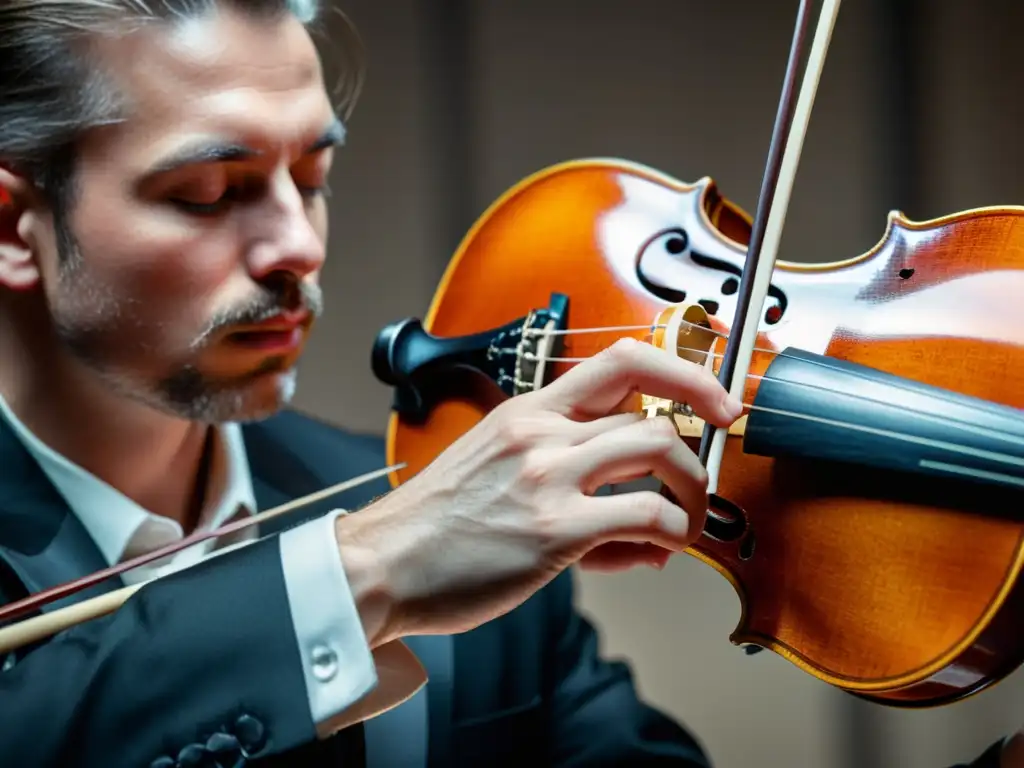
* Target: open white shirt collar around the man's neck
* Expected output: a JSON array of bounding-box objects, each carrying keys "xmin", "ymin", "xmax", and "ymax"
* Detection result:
[{"xmin": 0, "ymin": 397, "xmax": 257, "ymax": 565}]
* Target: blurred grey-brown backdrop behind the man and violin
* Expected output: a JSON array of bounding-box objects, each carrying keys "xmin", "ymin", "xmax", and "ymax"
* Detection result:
[{"xmin": 288, "ymin": 0, "xmax": 1024, "ymax": 768}]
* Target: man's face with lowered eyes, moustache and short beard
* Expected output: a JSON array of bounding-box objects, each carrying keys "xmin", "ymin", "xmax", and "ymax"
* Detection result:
[{"xmin": 23, "ymin": 6, "xmax": 341, "ymax": 421}]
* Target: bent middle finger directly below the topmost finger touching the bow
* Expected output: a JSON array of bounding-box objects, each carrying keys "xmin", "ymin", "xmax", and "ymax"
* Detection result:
[{"xmin": 558, "ymin": 417, "xmax": 708, "ymax": 525}]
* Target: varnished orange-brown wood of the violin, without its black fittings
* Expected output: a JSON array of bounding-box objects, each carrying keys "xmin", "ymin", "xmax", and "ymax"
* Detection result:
[{"xmin": 380, "ymin": 161, "xmax": 1024, "ymax": 705}]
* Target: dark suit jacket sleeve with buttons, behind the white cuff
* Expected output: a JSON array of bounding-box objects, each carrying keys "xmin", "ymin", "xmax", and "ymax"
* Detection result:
[{"xmin": 0, "ymin": 536, "xmax": 372, "ymax": 768}]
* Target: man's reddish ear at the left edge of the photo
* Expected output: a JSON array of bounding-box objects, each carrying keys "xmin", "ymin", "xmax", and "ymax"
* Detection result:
[{"xmin": 0, "ymin": 165, "xmax": 41, "ymax": 291}]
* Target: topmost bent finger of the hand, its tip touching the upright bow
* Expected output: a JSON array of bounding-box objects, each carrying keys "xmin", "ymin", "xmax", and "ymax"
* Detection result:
[{"xmin": 537, "ymin": 339, "xmax": 742, "ymax": 427}]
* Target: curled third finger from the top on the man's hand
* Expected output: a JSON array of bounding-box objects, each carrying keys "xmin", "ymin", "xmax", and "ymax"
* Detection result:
[{"xmin": 567, "ymin": 490, "xmax": 700, "ymax": 552}]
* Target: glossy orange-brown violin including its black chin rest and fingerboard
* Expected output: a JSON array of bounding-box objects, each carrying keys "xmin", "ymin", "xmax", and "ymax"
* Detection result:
[{"xmin": 374, "ymin": 160, "xmax": 1024, "ymax": 707}]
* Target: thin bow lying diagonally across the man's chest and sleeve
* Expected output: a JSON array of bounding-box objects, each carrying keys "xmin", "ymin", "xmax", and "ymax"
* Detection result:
[{"xmin": 0, "ymin": 464, "xmax": 406, "ymax": 654}]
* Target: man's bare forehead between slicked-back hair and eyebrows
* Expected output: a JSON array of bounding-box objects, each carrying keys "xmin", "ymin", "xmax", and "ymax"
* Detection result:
[{"xmin": 90, "ymin": 10, "xmax": 333, "ymax": 156}]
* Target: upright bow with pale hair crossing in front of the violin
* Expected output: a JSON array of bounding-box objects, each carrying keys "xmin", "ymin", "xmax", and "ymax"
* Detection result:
[{"xmin": 699, "ymin": 0, "xmax": 840, "ymax": 494}]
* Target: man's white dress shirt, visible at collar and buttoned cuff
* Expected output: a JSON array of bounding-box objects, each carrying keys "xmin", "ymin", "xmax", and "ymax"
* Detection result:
[{"xmin": 0, "ymin": 397, "xmax": 426, "ymax": 735}]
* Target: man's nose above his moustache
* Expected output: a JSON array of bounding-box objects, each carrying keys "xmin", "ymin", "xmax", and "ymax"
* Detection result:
[{"xmin": 246, "ymin": 170, "xmax": 327, "ymax": 282}]
